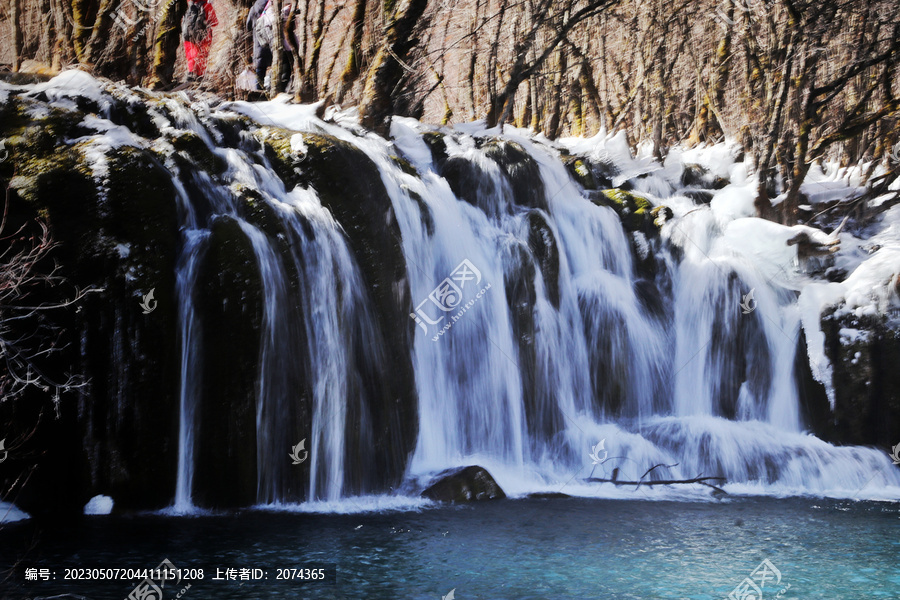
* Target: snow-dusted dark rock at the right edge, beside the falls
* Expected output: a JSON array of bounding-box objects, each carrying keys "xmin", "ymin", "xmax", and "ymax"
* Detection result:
[{"xmin": 813, "ymin": 311, "xmax": 900, "ymax": 448}]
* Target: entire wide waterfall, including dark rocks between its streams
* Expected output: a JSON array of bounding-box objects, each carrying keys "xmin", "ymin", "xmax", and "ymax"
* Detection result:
[{"xmin": 28, "ymin": 72, "xmax": 900, "ymax": 512}]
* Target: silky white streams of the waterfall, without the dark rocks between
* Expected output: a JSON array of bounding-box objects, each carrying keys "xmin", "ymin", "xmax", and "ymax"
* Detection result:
[{"xmin": 158, "ymin": 98, "xmax": 898, "ymax": 506}]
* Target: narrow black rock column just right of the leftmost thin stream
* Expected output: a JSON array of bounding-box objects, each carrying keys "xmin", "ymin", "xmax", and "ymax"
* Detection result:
[{"xmin": 193, "ymin": 217, "xmax": 263, "ymax": 508}]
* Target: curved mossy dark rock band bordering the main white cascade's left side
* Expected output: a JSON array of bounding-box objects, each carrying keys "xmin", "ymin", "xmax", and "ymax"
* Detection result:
[{"xmin": 262, "ymin": 128, "xmax": 418, "ymax": 486}]
